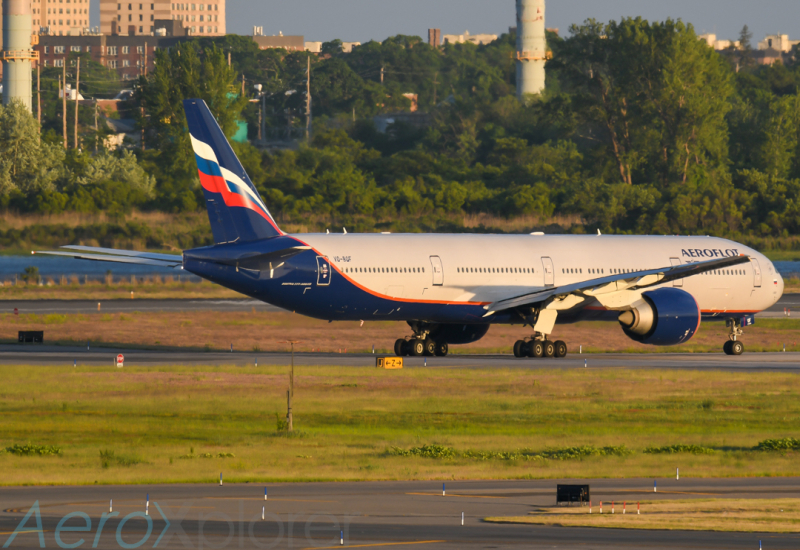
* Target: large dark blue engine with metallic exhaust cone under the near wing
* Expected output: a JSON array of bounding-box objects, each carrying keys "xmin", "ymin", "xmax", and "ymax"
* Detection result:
[{"xmin": 619, "ymin": 288, "xmax": 700, "ymax": 346}]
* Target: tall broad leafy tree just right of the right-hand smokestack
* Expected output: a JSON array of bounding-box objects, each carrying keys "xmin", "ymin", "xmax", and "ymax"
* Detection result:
[{"xmin": 553, "ymin": 18, "xmax": 733, "ymax": 185}]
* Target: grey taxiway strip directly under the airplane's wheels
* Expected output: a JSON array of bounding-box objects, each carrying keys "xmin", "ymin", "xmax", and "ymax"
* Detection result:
[{"xmin": 0, "ymin": 344, "xmax": 800, "ymax": 372}]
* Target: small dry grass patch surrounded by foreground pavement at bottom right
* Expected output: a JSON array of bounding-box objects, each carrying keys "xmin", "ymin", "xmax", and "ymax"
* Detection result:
[{"xmin": 486, "ymin": 498, "xmax": 800, "ymax": 533}]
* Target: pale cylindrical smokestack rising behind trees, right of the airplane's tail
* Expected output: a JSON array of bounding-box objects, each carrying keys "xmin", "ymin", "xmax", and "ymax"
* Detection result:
[{"xmin": 517, "ymin": 0, "xmax": 547, "ymax": 101}]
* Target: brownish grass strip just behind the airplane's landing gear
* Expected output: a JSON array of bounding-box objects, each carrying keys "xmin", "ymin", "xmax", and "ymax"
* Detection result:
[{"xmin": 0, "ymin": 306, "xmax": 800, "ymax": 354}]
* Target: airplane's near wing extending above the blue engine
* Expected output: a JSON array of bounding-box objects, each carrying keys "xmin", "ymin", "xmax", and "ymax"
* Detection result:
[{"xmin": 484, "ymin": 255, "xmax": 750, "ymax": 317}]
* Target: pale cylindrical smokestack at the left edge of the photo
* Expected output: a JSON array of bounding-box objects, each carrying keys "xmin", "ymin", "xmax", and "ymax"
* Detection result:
[{"xmin": 2, "ymin": 0, "xmax": 36, "ymax": 111}]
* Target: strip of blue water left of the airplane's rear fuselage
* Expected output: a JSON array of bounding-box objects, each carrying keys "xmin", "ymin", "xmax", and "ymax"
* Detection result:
[{"xmin": 0, "ymin": 255, "xmax": 199, "ymax": 282}]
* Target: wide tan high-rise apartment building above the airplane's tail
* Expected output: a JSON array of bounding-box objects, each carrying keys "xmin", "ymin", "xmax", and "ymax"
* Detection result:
[{"xmin": 101, "ymin": 0, "xmax": 226, "ymax": 36}]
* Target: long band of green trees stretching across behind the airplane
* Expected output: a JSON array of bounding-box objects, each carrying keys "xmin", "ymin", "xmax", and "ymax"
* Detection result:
[{"xmin": 0, "ymin": 18, "xmax": 800, "ymax": 248}]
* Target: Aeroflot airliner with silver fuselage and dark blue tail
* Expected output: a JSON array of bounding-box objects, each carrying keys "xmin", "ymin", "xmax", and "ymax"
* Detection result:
[{"xmin": 35, "ymin": 99, "xmax": 783, "ymax": 358}]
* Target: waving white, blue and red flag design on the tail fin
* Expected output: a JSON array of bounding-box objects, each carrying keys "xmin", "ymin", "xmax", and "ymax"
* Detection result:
[{"xmin": 189, "ymin": 134, "xmax": 277, "ymax": 229}]
